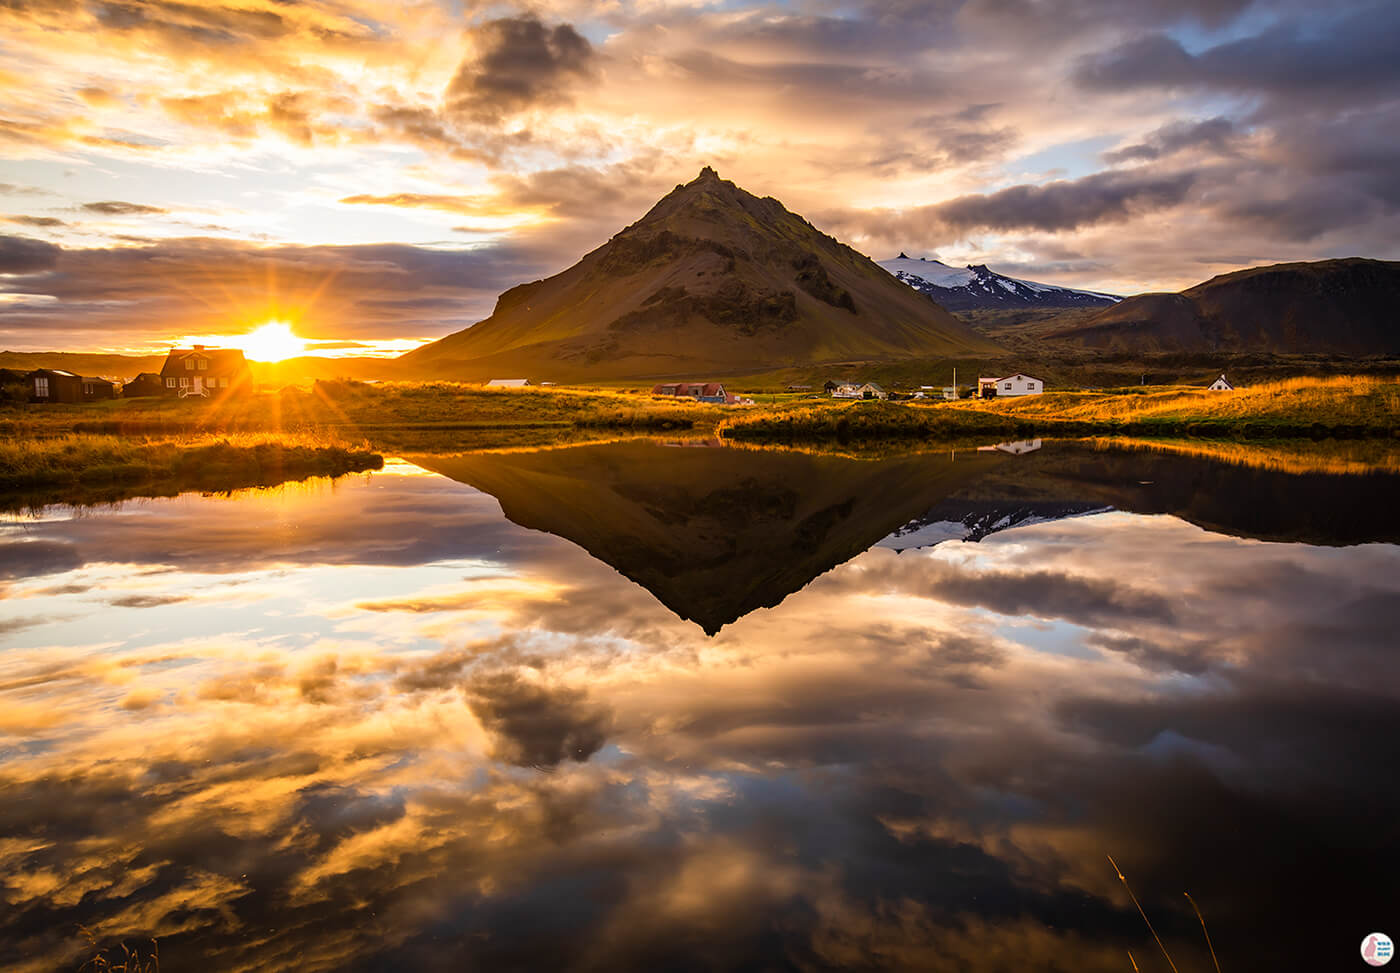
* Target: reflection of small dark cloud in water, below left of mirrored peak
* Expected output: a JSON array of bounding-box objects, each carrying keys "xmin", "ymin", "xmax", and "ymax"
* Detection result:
[{"xmin": 466, "ymin": 672, "xmax": 610, "ymax": 767}]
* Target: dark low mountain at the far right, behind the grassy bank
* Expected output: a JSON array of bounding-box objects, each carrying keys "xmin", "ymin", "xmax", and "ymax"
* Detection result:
[{"xmin": 1043, "ymin": 258, "xmax": 1400, "ymax": 356}]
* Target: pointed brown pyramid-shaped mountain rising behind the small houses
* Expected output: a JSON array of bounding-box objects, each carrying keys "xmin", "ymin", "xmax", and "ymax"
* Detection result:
[{"xmin": 399, "ymin": 167, "xmax": 1002, "ymax": 381}]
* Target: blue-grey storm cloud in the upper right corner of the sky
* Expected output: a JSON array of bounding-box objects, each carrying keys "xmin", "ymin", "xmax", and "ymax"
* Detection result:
[{"xmin": 1075, "ymin": 3, "xmax": 1400, "ymax": 102}]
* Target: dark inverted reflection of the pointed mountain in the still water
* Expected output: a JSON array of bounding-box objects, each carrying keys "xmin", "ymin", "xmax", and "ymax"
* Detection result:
[{"xmin": 413, "ymin": 442, "xmax": 1007, "ymax": 634}]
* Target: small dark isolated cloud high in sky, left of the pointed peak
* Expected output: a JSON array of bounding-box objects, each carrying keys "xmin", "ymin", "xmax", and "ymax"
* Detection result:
[{"xmin": 447, "ymin": 14, "xmax": 595, "ymax": 123}]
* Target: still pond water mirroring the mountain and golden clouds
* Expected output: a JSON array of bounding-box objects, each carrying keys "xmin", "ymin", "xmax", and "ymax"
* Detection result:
[{"xmin": 0, "ymin": 442, "xmax": 1400, "ymax": 973}]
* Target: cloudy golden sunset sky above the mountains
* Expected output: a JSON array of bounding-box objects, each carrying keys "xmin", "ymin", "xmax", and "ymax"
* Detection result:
[{"xmin": 0, "ymin": 0, "xmax": 1400, "ymax": 354}]
